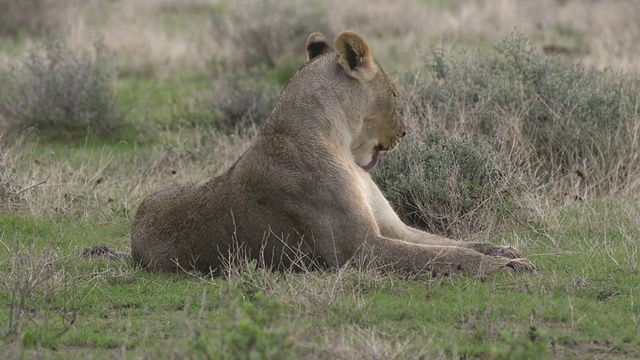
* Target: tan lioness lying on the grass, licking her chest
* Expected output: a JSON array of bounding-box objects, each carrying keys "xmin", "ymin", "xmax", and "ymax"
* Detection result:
[{"xmin": 131, "ymin": 32, "xmax": 535, "ymax": 274}]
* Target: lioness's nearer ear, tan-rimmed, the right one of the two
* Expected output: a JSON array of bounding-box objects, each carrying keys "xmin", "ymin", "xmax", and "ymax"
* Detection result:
[{"xmin": 336, "ymin": 31, "xmax": 380, "ymax": 81}]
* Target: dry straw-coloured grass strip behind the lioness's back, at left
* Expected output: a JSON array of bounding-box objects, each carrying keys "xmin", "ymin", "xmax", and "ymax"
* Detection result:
[{"xmin": 4, "ymin": 129, "xmax": 256, "ymax": 222}]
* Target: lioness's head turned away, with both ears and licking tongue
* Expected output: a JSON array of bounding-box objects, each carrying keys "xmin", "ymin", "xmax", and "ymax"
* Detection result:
[{"xmin": 307, "ymin": 31, "xmax": 405, "ymax": 172}]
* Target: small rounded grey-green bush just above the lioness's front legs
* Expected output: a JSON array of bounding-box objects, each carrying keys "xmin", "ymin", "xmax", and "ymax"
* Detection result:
[{"xmin": 373, "ymin": 131, "xmax": 527, "ymax": 238}]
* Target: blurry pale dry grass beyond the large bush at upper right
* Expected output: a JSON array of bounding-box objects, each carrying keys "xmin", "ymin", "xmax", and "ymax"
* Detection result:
[{"xmin": 327, "ymin": 0, "xmax": 640, "ymax": 72}]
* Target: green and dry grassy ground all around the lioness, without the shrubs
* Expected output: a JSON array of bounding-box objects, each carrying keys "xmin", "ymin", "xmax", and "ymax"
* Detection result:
[{"xmin": 0, "ymin": 0, "xmax": 640, "ymax": 359}]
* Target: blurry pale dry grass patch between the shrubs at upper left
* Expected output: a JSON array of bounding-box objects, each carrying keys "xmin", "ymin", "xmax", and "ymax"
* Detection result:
[{"xmin": 0, "ymin": 0, "xmax": 217, "ymax": 78}]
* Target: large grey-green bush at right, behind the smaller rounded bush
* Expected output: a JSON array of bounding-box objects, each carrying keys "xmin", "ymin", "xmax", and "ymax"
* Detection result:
[{"xmin": 406, "ymin": 34, "xmax": 640, "ymax": 193}]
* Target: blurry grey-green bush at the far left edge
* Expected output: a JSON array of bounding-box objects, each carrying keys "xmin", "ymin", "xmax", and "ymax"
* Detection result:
[{"xmin": 0, "ymin": 42, "xmax": 120, "ymax": 138}]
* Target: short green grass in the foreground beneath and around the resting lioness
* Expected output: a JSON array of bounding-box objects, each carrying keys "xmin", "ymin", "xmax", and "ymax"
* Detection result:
[{"xmin": 0, "ymin": 201, "xmax": 640, "ymax": 359}]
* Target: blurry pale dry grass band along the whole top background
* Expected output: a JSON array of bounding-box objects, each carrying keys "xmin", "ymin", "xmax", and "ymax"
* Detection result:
[{"xmin": 0, "ymin": 0, "xmax": 640, "ymax": 77}]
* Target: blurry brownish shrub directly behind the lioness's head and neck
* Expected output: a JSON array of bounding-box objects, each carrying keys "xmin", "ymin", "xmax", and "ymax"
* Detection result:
[{"xmin": 208, "ymin": 0, "xmax": 338, "ymax": 131}]
